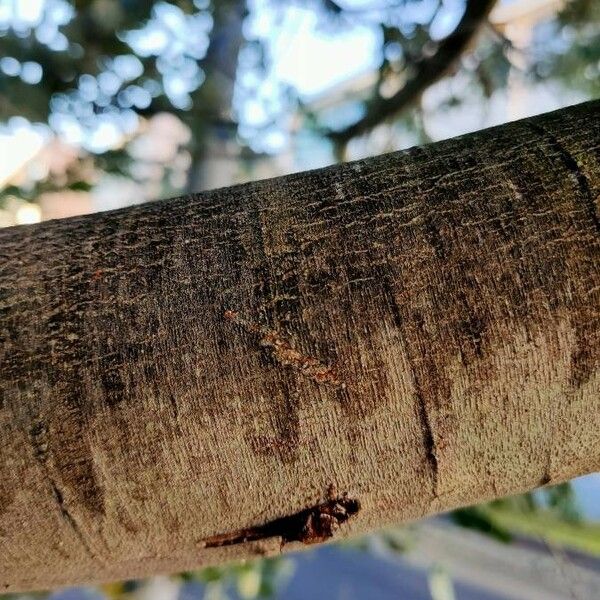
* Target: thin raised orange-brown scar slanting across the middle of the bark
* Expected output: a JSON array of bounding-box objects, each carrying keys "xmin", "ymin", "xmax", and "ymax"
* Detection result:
[{"xmin": 223, "ymin": 310, "xmax": 346, "ymax": 389}]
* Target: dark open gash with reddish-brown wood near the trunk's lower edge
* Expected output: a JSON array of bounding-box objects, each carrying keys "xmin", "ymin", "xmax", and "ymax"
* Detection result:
[{"xmin": 201, "ymin": 493, "xmax": 360, "ymax": 548}]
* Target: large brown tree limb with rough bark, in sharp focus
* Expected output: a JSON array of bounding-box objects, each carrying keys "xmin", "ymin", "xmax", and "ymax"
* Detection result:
[{"xmin": 0, "ymin": 101, "xmax": 600, "ymax": 590}]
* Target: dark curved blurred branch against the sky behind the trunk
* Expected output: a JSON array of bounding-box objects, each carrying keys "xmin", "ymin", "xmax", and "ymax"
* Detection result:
[{"xmin": 328, "ymin": 0, "xmax": 495, "ymax": 146}]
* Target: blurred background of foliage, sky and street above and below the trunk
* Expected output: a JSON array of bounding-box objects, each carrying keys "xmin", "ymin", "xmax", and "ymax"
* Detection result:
[{"xmin": 0, "ymin": 0, "xmax": 600, "ymax": 600}]
